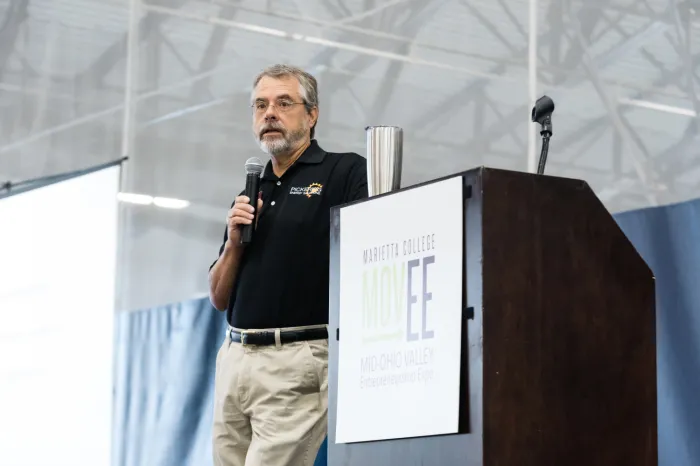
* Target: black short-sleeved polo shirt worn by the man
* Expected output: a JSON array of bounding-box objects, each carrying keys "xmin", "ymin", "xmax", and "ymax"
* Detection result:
[{"xmin": 211, "ymin": 140, "xmax": 368, "ymax": 329}]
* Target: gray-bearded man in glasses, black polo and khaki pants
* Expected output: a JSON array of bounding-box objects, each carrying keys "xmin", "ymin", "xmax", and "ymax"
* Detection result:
[{"xmin": 209, "ymin": 65, "xmax": 367, "ymax": 466}]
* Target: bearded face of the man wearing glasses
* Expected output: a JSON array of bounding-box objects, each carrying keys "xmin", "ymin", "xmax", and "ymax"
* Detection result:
[{"xmin": 253, "ymin": 76, "xmax": 317, "ymax": 155}]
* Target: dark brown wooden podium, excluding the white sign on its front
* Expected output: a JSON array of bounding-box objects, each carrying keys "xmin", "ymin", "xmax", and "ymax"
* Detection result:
[{"xmin": 328, "ymin": 168, "xmax": 657, "ymax": 466}]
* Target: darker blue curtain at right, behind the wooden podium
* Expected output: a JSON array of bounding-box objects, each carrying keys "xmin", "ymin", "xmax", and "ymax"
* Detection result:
[{"xmin": 616, "ymin": 199, "xmax": 700, "ymax": 466}]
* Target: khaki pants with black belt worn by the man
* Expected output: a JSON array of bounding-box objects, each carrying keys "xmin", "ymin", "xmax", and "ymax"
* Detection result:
[{"xmin": 213, "ymin": 328, "xmax": 328, "ymax": 466}]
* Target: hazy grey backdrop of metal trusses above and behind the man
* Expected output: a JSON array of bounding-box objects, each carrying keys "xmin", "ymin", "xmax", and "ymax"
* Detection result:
[{"xmin": 0, "ymin": 0, "xmax": 700, "ymax": 310}]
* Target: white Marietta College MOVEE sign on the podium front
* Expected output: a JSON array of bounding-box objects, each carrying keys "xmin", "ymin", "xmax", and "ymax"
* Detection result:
[{"xmin": 336, "ymin": 176, "xmax": 464, "ymax": 443}]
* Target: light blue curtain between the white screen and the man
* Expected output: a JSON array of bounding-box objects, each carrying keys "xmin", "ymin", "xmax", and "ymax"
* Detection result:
[{"xmin": 112, "ymin": 298, "xmax": 326, "ymax": 466}]
